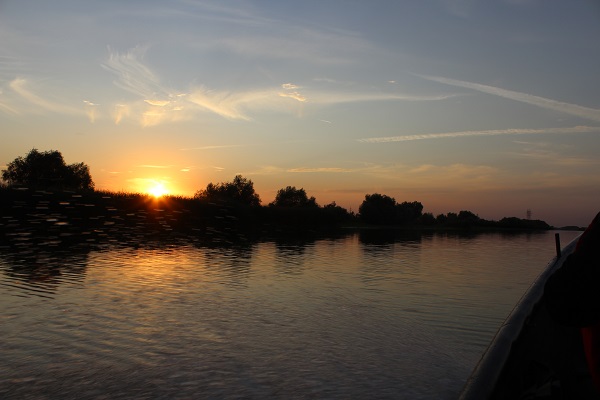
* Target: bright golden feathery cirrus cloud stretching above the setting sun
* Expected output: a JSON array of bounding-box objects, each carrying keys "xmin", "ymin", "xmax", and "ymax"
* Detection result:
[{"xmin": 102, "ymin": 46, "xmax": 456, "ymax": 126}]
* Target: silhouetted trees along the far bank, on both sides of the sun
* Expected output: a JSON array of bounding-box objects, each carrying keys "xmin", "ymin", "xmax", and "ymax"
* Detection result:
[{"xmin": 2, "ymin": 149, "xmax": 550, "ymax": 229}]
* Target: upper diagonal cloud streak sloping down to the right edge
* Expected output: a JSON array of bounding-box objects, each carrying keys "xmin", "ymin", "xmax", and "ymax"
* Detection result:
[{"xmin": 416, "ymin": 74, "xmax": 600, "ymax": 121}]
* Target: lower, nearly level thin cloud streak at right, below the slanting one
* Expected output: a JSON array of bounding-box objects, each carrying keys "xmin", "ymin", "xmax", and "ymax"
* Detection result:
[{"xmin": 358, "ymin": 126, "xmax": 600, "ymax": 143}]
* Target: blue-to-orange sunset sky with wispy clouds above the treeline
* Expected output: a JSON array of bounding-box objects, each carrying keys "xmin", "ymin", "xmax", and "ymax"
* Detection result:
[{"xmin": 0, "ymin": 0, "xmax": 600, "ymax": 226}]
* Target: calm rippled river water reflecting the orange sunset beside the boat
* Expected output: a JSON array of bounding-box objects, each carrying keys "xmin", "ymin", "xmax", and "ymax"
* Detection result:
[{"xmin": 0, "ymin": 231, "xmax": 578, "ymax": 399}]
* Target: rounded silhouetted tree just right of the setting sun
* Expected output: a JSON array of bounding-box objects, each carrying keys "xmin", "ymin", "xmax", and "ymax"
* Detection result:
[{"xmin": 194, "ymin": 175, "xmax": 260, "ymax": 207}]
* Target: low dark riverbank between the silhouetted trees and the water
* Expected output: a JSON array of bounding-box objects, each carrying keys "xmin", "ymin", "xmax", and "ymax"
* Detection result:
[{"xmin": 0, "ymin": 188, "xmax": 579, "ymax": 250}]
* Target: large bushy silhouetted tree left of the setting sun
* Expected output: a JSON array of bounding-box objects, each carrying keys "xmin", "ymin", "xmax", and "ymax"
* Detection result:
[{"xmin": 2, "ymin": 149, "xmax": 94, "ymax": 190}]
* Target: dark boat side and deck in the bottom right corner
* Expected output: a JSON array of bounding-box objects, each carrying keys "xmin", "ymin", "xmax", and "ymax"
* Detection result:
[{"xmin": 460, "ymin": 236, "xmax": 600, "ymax": 400}]
